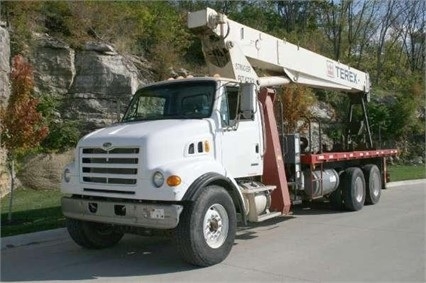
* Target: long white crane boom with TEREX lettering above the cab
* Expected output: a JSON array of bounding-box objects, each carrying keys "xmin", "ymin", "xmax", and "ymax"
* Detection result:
[{"xmin": 188, "ymin": 8, "xmax": 370, "ymax": 94}]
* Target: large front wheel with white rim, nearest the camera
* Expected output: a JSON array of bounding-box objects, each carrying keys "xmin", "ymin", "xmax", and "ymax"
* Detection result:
[{"xmin": 174, "ymin": 185, "xmax": 237, "ymax": 266}]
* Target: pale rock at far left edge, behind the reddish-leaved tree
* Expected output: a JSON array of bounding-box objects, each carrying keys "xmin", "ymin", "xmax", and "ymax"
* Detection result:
[{"xmin": 0, "ymin": 26, "xmax": 10, "ymax": 197}]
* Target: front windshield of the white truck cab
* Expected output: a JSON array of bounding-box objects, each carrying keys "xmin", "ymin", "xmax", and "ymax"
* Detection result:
[{"xmin": 122, "ymin": 81, "xmax": 216, "ymax": 122}]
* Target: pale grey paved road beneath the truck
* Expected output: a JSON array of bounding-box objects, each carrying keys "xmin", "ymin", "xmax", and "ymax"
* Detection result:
[{"xmin": 1, "ymin": 180, "xmax": 426, "ymax": 282}]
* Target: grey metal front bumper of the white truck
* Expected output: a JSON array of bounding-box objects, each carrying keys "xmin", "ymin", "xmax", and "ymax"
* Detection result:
[{"xmin": 61, "ymin": 197, "xmax": 183, "ymax": 229}]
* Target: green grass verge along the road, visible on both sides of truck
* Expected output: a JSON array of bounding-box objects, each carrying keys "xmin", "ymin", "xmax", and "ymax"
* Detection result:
[{"xmin": 1, "ymin": 165, "xmax": 426, "ymax": 237}]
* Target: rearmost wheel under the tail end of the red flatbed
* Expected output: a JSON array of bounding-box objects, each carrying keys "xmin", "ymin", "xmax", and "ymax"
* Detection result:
[{"xmin": 362, "ymin": 164, "xmax": 382, "ymax": 204}]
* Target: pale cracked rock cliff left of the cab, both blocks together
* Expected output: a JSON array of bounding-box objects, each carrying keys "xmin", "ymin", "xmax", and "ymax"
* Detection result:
[{"xmin": 30, "ymin": 37, "xmax": 153, "ymax": 133}]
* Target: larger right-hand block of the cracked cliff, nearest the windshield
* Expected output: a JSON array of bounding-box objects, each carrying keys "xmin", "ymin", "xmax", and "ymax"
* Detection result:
[{"xmin": 66, "ymin": 43, "xmax": 147, "ymax": 131}]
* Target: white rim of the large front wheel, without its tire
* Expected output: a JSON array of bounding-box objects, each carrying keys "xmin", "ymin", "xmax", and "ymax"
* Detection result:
[{"xmin": 203, "ymin": 204, "xmax": 229, "ymax": 249}]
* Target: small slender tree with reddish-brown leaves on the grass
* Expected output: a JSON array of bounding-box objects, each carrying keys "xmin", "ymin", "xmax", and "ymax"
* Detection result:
[{"xmin": 0, "ymin": 55, "xmax": 48, "ymax": 221}]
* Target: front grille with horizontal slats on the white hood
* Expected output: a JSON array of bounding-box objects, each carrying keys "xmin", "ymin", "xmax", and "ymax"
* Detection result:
[{"xmin": 80, "ymin": 148, "xmax": 139, "ymax": 185}]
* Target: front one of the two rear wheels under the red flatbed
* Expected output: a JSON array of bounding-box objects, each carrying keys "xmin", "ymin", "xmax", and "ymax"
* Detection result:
[{"xmin": 343, "ymin": 167, "xmax": 365, "ymax": 211}]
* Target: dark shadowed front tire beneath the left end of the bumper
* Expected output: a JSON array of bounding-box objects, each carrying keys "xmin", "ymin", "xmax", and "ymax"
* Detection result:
[{"xmin": 66, "ymin": 218, "xmax": 124, "ymax": 249}]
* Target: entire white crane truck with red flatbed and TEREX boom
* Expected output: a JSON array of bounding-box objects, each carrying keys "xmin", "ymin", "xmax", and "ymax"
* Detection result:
[{"xmin": 61, "ymin": 8, "xmax": 397, "ymax": 266}]
